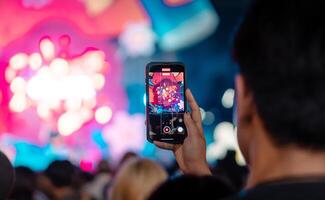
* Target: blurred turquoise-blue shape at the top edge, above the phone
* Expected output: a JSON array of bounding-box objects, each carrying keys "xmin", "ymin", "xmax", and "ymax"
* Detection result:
[{"xmin": 141, "ymin": 0, "xmax": 219, "ymax": 51}]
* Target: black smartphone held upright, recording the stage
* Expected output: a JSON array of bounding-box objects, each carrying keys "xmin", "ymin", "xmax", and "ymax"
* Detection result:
[{"xmin": 145, "ymin": 62, "xmax": 187, "ymax": 144}]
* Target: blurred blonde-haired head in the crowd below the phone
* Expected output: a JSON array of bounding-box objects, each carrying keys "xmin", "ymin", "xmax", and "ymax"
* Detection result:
[{"xmin": 109, "ymin": 158, "xmax": 167, "ymax": 200}]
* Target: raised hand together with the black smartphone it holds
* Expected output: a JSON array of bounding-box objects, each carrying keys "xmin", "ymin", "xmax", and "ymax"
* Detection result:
[{"xmin": 146, "ymin": 66, "xmax": 211, "ymax": 175}]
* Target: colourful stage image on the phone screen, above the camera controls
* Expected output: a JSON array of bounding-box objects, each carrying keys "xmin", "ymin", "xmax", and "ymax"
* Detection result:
[{"xmin": 149, "ymin": 68, "xmax": 185, "ymax": 114}]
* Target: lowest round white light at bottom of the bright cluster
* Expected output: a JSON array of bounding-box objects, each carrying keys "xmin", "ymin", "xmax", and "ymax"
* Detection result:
[{"xmin": 58, "ymin": 112, "xmax": 82, "ymax": 136}]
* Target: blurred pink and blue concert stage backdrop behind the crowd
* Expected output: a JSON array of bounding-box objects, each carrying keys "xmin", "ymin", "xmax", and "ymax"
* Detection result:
[{"xmin": 0, "ymin": 0, "xmax": 247, "ymax": 171}]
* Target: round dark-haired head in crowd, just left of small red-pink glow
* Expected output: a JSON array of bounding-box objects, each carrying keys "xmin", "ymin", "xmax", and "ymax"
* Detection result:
[{"xmin": 44, "ymin": 160, "xmax": 75, "ymax": 188}]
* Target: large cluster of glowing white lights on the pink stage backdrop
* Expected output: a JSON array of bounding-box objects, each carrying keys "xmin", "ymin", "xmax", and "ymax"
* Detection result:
[{"xmin": 6, "ymin": 38, "xmax": 108, "ymax": 136}]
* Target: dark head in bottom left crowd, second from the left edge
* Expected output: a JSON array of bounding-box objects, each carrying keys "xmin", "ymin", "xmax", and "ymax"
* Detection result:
[{"xmin": 10, "ymin": 167, "xmax": 36, "ymax": 200}]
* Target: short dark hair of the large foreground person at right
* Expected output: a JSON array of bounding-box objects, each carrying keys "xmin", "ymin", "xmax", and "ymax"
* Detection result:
[{"xmin": 234, "ymin": 0, "xmax": 325, "ymax": 149}]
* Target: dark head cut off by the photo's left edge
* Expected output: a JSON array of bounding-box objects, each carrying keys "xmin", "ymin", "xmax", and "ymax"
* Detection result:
[{"xmin": 0, "ymin": 151, "xmax": 15, "ymax": 199}]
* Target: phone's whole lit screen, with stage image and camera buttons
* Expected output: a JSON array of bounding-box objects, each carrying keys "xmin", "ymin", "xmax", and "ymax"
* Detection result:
[{"xmin": 148, "ymin": 67, "xmax": 185, "ymax": 135}]
